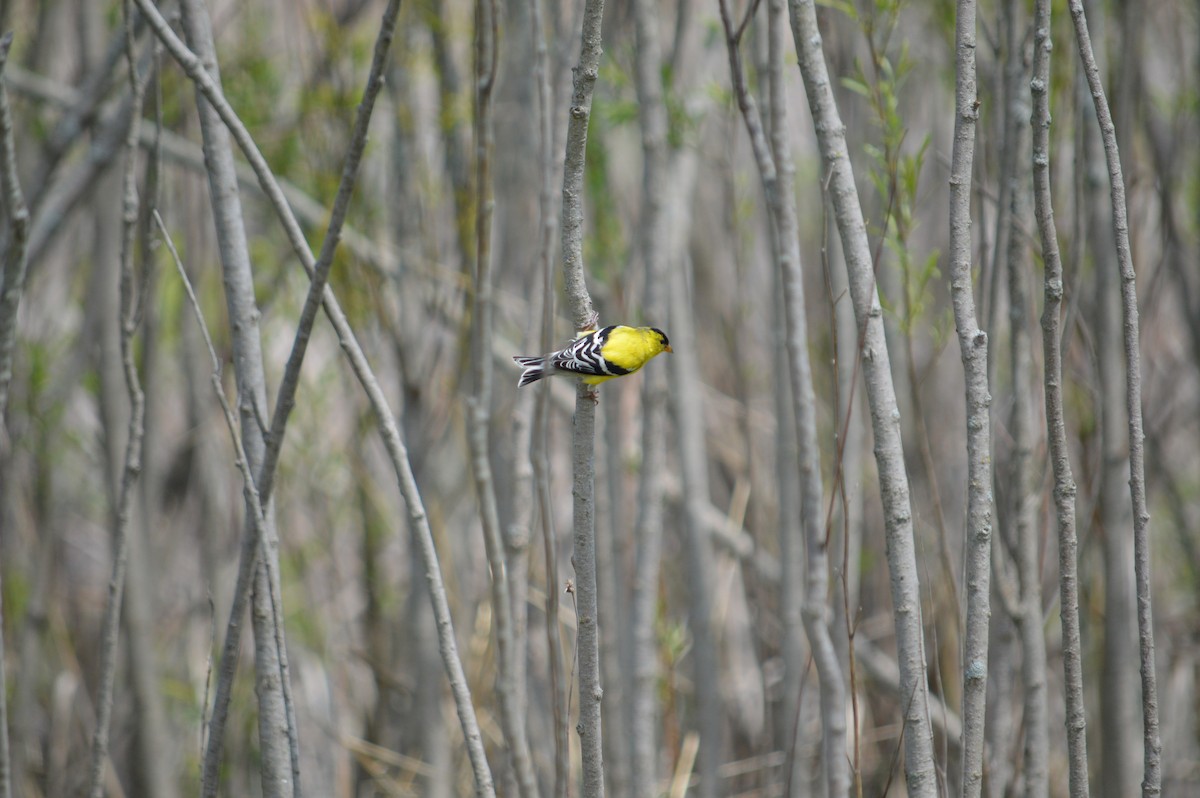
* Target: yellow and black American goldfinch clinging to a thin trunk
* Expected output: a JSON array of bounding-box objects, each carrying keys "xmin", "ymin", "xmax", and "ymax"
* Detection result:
[{"xmin": 512, "ymin": 324, "xmax": 671, "ymax": 388}]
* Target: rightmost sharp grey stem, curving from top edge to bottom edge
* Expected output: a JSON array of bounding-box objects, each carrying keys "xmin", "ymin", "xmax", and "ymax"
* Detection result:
[{"xmin": 1068, "ymin": 0, "xmax": 1163, "ymax": 796}]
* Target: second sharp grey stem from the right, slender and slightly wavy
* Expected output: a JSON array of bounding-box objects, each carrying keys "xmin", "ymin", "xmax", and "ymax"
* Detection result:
[{"xmin": 1030, "ymin": 0, "xmax": 1088, "ymax": 798}]
